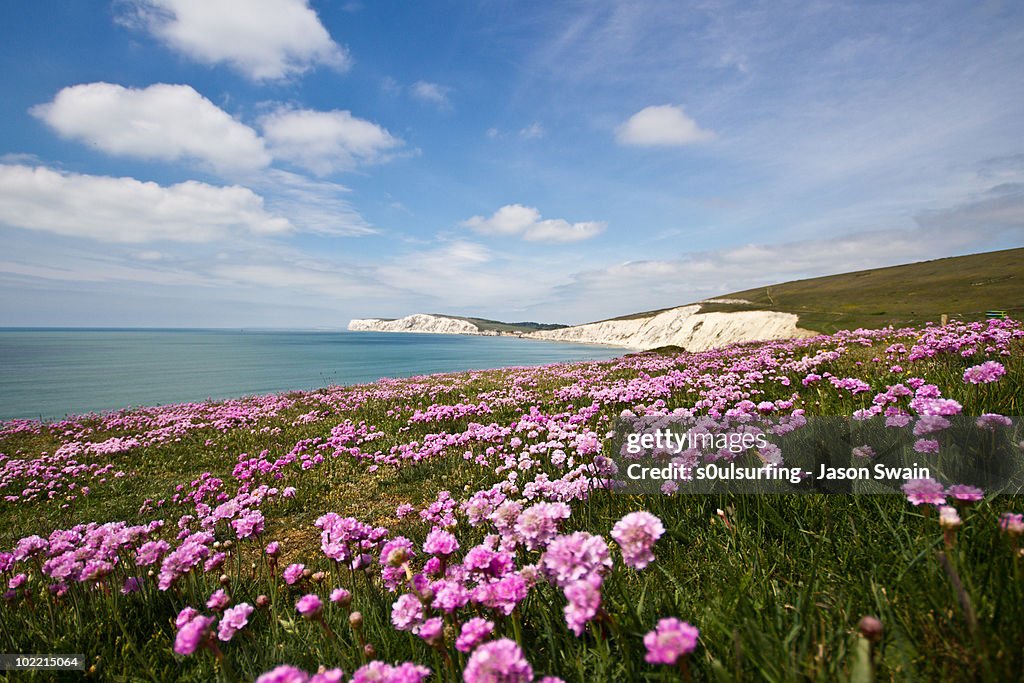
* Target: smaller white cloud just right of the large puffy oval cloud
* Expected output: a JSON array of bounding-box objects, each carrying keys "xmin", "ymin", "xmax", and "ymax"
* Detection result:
[{"xmin": 260, "ymin": 109, "xmax": 402, "ymax": 175}]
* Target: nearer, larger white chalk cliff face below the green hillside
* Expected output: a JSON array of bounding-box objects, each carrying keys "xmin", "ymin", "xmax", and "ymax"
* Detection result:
[{"xmin": 523, "ymin": 305, "xmax": 813, "ymax": 351}]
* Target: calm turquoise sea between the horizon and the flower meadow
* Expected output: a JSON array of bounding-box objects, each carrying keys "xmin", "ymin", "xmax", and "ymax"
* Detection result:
[{"xmin": 0, "ymin": 329, "xmax": 624, "ymax": 420}]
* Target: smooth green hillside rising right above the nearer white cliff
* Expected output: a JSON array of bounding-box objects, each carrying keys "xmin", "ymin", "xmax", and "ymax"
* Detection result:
[{"xmin": 598, "ymin": 249, "xmax": 1024, "ymax": 333}]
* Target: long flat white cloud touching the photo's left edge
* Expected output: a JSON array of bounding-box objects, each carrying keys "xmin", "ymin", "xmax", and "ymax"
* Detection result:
[{"xmin": 0, "ymin": 165, "xmax": 294, "ymax": 243}]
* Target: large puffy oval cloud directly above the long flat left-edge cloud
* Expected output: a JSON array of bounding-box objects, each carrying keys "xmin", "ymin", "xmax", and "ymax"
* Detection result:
[{"xmin": 31, "ymin": 83, "xmax": 270, "ymax": 171}]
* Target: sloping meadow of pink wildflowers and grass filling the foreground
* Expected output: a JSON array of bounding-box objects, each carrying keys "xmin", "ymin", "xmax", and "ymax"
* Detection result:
[{"xmin": 0, "ymin": 319, "xmax": 1024, "ymax": 683}]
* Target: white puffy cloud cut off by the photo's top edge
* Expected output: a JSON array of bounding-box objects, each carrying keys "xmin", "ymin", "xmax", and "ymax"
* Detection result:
[{"xmin": 120, "ymin": 0, "xmax": 351, "ymax": 81}]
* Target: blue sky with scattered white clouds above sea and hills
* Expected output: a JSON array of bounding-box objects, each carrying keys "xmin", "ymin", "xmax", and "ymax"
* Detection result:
[{"xmin": 0, "ymin": 0, "xmax": 1024, "ymax": 328}]
